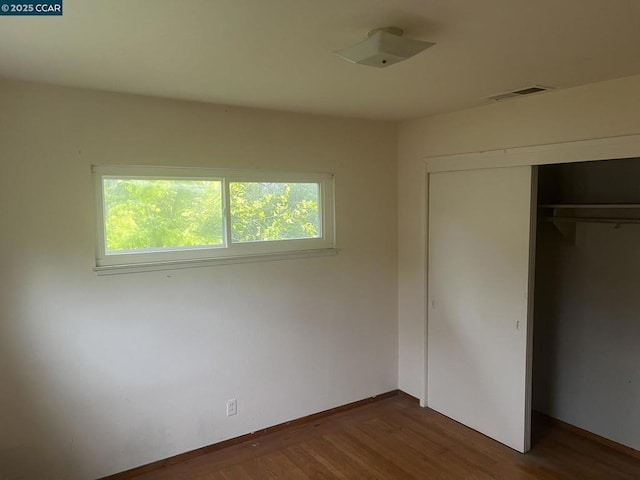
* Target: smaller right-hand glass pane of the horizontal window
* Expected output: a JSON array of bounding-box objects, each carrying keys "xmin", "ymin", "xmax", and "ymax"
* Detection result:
[{"xmin": 229, "ymin": 182, "xmax": 322, "ymax": 243}]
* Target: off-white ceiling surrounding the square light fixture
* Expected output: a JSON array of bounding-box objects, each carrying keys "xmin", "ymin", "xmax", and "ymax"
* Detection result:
[{"xmin": 0, "ymin": 0, "xmax": 640, "ymax": 120}]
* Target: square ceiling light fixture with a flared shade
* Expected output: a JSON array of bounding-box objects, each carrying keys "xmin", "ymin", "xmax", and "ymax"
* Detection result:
[{"xmin": 335, "ymin": 27, "xmax": 435, "ymax": 67}]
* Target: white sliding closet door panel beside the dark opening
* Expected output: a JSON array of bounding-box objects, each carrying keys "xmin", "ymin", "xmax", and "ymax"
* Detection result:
[{"xmin": 427, "ymin": 166, "xmax": 535, "ymax": 452}]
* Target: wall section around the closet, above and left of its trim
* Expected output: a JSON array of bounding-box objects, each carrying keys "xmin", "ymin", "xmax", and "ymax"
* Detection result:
[{"xmin": 398, "ymin": 76, "xmax": 640, "ymax": 398}]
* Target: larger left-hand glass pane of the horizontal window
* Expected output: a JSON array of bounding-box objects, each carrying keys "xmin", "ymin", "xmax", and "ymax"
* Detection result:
[{"xmin": 103, "ymin": 177, "xmax": 224, "ymax": 253}]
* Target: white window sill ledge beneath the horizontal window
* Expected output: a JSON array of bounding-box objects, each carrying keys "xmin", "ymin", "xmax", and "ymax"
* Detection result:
[{"xmin": 93, "ymin": 248, "xmax": 338, "ymax": 276}]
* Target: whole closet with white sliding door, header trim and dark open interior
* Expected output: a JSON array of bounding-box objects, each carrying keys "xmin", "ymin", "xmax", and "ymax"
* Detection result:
[{"xmin": 425, "ymin": 148, "xmax": 640, "ymax": 452}]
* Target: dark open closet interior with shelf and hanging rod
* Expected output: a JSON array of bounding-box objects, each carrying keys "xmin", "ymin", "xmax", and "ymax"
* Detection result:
[{"xmin": 532, "ymin": 159, "xmax": 640, "ymax": 449}]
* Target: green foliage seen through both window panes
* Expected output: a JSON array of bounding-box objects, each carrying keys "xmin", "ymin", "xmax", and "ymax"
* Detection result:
[{"xmin": 103, "ymin": 178, "xmax": 320, "ymax": 252}]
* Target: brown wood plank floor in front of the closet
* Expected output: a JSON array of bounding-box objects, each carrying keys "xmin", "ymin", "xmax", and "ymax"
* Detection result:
[{"xmin": 125, "ymin": 397, "xmax": 640, "ymax": 480}]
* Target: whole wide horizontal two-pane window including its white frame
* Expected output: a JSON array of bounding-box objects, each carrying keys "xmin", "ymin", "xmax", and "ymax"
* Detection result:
[{"xmin": 93, "ymin": 166, "xmax": 334, "ymax": 271}]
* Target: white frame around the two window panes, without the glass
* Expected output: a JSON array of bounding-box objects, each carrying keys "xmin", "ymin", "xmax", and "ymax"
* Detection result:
[{"xmin": 91, "ymin": 165, "xmax": 336, "ymax": 274}]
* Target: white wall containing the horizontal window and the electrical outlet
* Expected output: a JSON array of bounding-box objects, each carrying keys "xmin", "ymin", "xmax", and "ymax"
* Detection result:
[{"xmin": 0, "ymin": 82, "xmax": 398, "ymax": 480}]
